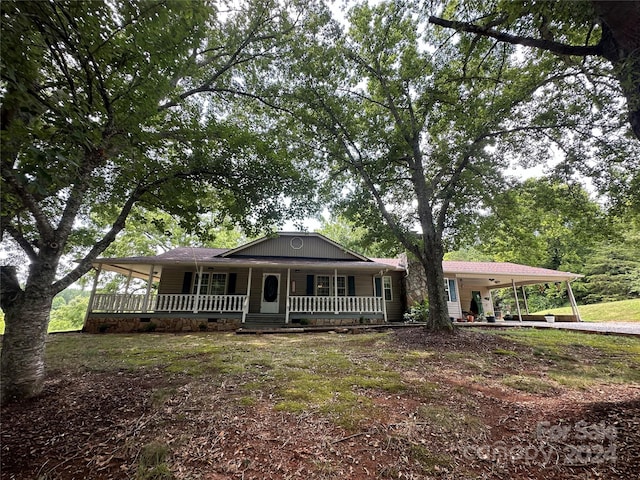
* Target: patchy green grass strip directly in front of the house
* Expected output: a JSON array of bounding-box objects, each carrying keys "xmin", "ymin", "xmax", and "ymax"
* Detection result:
[{"xmin": 41, "ymin": 329, "xmax": 640, "ymax": 414}]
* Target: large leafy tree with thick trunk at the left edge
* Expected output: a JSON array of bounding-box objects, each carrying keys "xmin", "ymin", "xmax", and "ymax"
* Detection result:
[{"xmin": 0, "ymin": 0, "xmax": 313, "ymax": 403}]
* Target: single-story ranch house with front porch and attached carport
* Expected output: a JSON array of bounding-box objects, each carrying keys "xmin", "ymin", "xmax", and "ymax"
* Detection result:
[{"xmin": 84, "ymin": 232, "xmax": 580, "ymax": 332}]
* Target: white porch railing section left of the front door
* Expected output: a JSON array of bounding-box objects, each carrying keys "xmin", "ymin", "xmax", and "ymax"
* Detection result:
[{"xmin": 91, "ymin": 293, "xmax": 248, "ymax": 313}]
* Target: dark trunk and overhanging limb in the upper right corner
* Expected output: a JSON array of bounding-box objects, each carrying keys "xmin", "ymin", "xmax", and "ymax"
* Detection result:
[{"xmin": 429, "ymin": 0, "xmax": 640, "ymax": 140}]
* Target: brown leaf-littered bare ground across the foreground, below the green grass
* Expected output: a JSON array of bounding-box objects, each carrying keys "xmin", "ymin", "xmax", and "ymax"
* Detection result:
[{"xmin": 0, "ymin": 329, "xmax": 640, "ymax": 480}]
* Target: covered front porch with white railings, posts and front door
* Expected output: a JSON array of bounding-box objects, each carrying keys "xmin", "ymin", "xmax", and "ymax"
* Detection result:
[{"xmin": 85, "ymin": 257, "xmax": 391, "ymax": 331}]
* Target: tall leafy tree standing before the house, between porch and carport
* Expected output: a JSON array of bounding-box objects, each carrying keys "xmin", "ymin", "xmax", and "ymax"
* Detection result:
[{"xmin": 278, "ymin": 2, "xmax": 626, "ymax": 330}]
